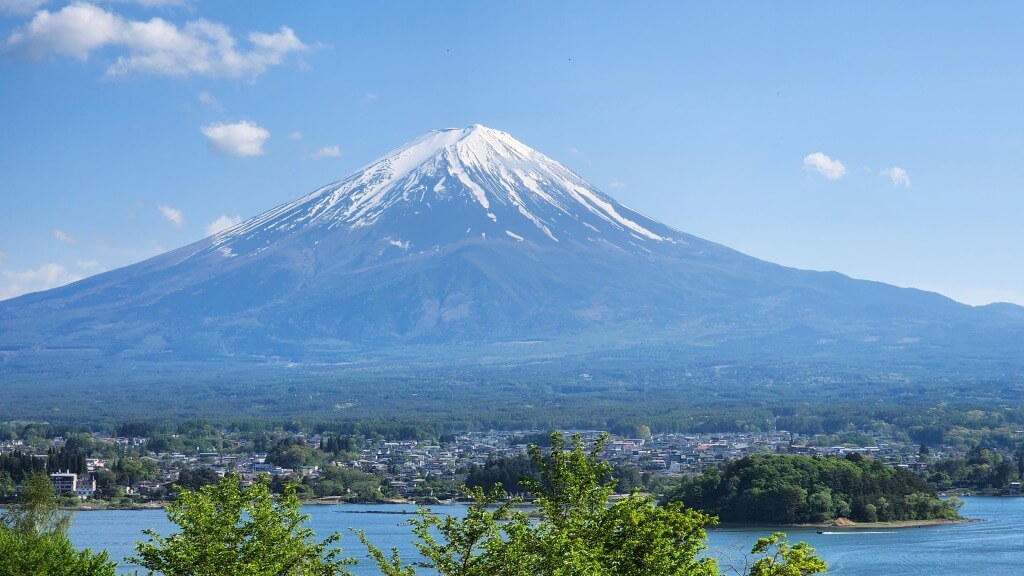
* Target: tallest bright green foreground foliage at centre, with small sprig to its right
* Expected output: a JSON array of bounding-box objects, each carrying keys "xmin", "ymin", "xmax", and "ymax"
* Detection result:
[{"xmin": 359, "ymin": 434, "xmax": 824, "ymax": 576}]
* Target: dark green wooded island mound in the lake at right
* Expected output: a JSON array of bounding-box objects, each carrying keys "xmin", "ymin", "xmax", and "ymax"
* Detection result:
[{"xmin": 668, "ymin": 454, "xmax": 959, "ymax": 524}]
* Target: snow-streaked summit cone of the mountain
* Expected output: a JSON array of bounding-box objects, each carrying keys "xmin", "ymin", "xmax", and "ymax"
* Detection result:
[{"xmin": 195, "ymin": 125, "xmax": 685, "ymax": 262}]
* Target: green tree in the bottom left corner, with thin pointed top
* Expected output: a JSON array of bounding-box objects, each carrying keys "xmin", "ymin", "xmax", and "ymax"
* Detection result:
[{"xmin": 0, "ymin": 474, "xmax": 115, "ymax": 576}]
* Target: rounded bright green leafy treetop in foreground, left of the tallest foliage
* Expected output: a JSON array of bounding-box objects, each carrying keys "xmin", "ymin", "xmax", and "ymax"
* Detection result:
[{"xmin": 130, "ymin": 475, "xmax": 353, "ymax": 576}]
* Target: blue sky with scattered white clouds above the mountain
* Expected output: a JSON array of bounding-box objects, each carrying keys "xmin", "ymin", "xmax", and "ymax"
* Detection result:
[{"xmin": 0, "ymin": 0, "xmax": 1024, "ymax": 303}]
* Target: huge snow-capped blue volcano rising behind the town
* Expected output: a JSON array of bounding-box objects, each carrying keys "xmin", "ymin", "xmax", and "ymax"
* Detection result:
[{"xmin": 0, "ymin": 125, "xmax": 1024, "ymax": 373}]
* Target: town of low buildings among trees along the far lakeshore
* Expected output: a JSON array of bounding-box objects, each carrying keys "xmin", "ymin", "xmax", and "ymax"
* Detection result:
[{"xmin": 0, "ymin": 426, "xmax": 1024, "ymax": 507}]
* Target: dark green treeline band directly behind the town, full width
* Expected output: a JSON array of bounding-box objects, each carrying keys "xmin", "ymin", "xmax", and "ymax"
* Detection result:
[{"xmin": 0, "ymin": 397, "xmax": 1024, "ymax": 452}]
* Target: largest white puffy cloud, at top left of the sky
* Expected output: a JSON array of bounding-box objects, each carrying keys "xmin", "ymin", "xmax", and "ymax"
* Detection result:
[{"xmin": 6, "ymin": 0, "xmax": 307, "ymax": 78}]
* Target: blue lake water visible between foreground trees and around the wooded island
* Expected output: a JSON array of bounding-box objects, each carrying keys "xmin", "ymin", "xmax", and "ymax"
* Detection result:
[{"xmin": 71, "ymin": 497, "xmax": 1024, "ymax": 576}]
